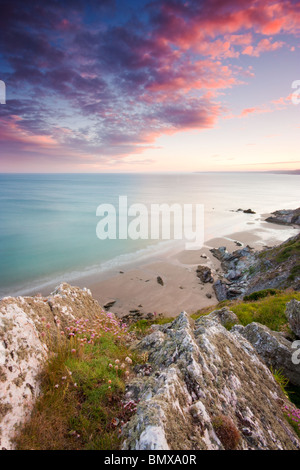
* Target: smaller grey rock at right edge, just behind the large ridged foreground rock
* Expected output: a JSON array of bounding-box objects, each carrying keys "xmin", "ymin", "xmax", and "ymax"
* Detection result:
[{"xmin": 233, "ymin": 322, "xmax": 300, "ymax": 386}]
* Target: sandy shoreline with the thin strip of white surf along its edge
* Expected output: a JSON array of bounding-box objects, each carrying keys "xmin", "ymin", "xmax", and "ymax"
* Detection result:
[{"xmin": 6, "ymin": 209, "xmax": 297, "ymax": 318}]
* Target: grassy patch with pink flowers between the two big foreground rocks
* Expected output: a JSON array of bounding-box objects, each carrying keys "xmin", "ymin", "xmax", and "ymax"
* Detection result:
[{"xmin": 16, "ymin": 312, "xmax": 136, "ymax": 450}]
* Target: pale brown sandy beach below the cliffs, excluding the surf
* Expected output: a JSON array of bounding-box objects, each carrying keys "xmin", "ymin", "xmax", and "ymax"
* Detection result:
[{"xmin": 80, "ymin": 221, "xmax": 297, "ymax": 317}]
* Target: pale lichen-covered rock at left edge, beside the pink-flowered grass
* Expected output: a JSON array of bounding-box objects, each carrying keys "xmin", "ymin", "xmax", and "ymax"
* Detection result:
[{"xmin": 0, "ymin": 284, "xmax": 102, "ymax": 449}]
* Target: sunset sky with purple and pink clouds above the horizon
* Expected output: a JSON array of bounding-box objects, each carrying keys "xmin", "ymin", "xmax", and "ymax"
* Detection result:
[{"xmin": 0, "ymin": 0, "xmax": 300, "ymax": 173}]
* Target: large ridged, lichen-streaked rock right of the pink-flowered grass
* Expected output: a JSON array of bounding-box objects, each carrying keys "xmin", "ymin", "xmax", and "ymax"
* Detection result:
[{"xmin": 122, "ymin": 311, "xmax": 300, "ymax": 450}]
